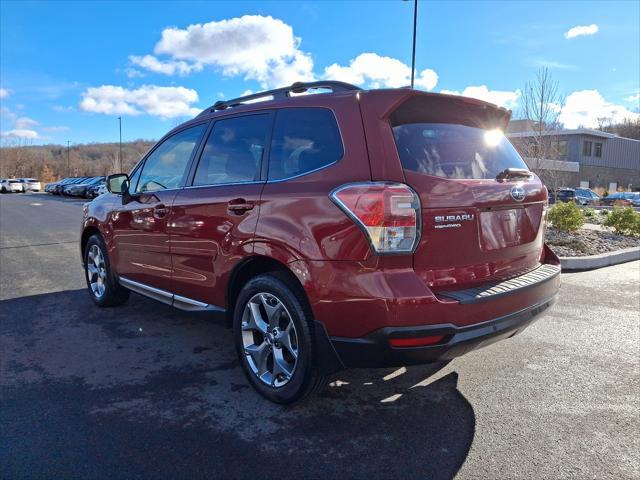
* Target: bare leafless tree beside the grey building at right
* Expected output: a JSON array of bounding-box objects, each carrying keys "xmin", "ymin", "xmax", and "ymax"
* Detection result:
[{"xmin": 514, "ymin": 67, "xmax": 566, "ymax": 195}]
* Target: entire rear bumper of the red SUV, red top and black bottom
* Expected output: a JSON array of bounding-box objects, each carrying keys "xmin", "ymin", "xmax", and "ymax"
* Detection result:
[{"xmin": 293, "ymin": 246, "xmax": 561, "ymax": 368}]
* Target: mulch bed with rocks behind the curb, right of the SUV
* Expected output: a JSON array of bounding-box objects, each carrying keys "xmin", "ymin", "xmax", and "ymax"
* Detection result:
[{"xmin": 546, "ymin": 226, "xmax": 640, "ymax": 257}]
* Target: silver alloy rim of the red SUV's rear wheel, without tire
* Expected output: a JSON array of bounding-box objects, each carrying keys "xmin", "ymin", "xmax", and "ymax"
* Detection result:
[{"xmin": 242, "ymin": 293, "xmax": 298, "ymax": 388}]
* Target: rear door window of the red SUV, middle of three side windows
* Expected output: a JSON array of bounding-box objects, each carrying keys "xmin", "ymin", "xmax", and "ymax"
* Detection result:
[{"xmin": 193, "ymin": 114, "xmax": 271, "ymax": 185}]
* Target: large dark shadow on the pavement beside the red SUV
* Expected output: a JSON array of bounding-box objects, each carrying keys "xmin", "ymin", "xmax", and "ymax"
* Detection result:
[{"xmin": 0, "ymin": 290, "xmax": 475, "ymax": 479}]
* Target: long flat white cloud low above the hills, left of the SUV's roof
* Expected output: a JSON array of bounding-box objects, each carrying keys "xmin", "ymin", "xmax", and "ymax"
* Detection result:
[{"xmin": 80, "ymin": 85, "xmax": 200, "ymax": 119}]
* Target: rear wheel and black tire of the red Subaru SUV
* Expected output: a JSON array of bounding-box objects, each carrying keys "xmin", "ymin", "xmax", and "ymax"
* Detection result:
[{"xmin": 233, "ymin": 272, "xmax": 326, "ymax": 404}]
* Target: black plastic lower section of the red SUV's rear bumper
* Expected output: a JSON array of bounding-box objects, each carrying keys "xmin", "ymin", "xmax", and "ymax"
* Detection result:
[{"xmin": 331, "ymin": 294, "xmax": 557, "ymax": 368}]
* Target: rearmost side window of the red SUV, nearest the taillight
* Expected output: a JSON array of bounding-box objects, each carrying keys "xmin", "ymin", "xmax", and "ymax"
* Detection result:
[{"xmin": 269, "ymin": 108, "xmax": 344, "ymax": 180}]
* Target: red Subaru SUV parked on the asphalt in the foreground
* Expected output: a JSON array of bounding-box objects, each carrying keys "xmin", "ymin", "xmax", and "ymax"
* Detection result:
[{"xmin": 81, "ymin": 82, "xmax": 560, "ymax": 403}]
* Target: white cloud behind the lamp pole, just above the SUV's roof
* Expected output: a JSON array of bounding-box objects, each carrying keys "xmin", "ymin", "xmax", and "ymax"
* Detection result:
[{"xmin": 324, "ymin": 53, "xmax": 438, "ymax": 90}]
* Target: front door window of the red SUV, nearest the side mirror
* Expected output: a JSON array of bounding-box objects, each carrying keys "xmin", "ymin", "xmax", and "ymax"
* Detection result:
[{"xmin": 135, "ymin": 123, "xmax": 207, "ymax": 192}]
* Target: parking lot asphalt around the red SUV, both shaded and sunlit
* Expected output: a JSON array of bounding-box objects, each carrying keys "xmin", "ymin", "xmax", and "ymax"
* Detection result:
[{"xmin": 0, "ymin": 194, "xmax": 640, "ymax": 479}]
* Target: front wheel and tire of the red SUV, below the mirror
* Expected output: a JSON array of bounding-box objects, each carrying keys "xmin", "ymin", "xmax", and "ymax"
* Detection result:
[{"xmin": 84, "ymin": 234, "xmax": 129, "ymax": 307}]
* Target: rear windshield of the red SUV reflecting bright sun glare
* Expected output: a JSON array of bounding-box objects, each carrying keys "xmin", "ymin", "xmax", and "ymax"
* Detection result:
[{"xmin": 393, "ymin": 123, "xmax": 528, "ymax": 179}]
